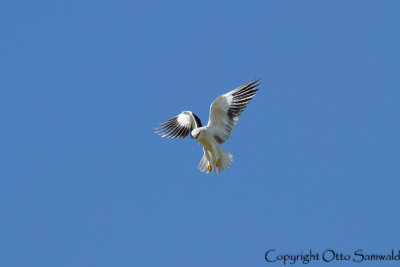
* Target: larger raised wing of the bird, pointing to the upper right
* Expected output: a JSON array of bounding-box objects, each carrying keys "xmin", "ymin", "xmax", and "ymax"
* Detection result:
[{"xmin": 207, "ymin": 80, "xmax": 260, "ymax": 144}]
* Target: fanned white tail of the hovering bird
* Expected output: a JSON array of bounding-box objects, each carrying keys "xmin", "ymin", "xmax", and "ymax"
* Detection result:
[{"xmin": 198, "ymin": 147, "xmax": 233, "ymax": 173}]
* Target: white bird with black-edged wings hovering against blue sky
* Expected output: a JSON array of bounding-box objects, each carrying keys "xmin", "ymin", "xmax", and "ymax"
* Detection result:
[{"xmin": 155, "ymin": 79, "xmax": 261, "ymax": 174}]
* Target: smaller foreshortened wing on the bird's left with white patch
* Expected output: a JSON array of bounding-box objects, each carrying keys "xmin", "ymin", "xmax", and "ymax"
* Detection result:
[{"xmin": 156, "ymin": 111, "xmax": 201, "ymax": 138}]
